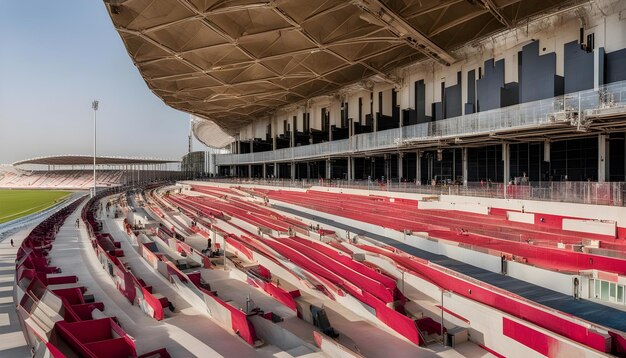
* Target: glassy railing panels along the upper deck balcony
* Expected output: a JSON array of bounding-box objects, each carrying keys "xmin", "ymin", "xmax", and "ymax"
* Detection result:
[{"xmin": 215, "ymin": 81, "xmax": 626, "ymax": 165}]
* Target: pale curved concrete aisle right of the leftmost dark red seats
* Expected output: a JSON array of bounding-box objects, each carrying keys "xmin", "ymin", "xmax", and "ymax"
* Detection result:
[{"xmin": 50, "ymin": 201, "xmax": 269, "ymax": 357}]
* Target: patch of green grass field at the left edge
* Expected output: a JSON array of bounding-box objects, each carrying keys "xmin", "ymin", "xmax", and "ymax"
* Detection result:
[{"xmin": 0, "ymin": 190, "xmax": 72, "ymax": 223}]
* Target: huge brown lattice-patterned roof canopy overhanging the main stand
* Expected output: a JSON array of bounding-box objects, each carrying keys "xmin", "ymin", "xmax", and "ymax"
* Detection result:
[{"xmin": 104, "ymin": 0, "xmax": 580, "ymax": 145}]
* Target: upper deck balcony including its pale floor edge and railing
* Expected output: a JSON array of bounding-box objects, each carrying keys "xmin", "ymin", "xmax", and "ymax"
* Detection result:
[{"xmin": 215, "ymin": 81, "xmax": 626, "ymax": 165}]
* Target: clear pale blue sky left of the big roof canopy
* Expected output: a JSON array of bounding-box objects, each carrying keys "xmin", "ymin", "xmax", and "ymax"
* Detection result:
[{"xmin": 0, "ymin": 0, "xmax": 207, "ymax": 164}]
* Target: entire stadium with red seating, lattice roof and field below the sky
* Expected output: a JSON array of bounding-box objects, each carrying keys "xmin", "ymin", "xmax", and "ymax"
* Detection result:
[{"xmin": 0, "ymin": 0, "xmax": 626, "ymax": 358}]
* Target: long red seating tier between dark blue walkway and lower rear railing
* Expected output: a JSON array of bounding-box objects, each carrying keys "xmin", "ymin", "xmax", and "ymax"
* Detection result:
[{"xmin": 266, "ymin": 190, "xmax": 626, "ymax": 274}]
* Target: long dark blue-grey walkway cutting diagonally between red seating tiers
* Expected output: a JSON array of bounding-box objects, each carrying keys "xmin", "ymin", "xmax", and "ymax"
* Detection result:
[{"xmin": 272, "ymin": 204, "xmax": 626, "ymax": 332}]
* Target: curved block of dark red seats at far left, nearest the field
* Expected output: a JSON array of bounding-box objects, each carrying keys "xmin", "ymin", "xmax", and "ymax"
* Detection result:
[{"xmin": 15, "ymin": 200, "xmax": 169, "ymax": 357}]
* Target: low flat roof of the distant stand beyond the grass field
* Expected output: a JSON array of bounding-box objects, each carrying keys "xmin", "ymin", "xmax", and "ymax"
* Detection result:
[{"xmin": 12, "ymin": 155, "xmax": 178, "ymax": 166}]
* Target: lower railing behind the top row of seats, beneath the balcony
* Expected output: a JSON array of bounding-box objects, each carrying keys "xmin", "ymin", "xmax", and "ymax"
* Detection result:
[{"xmin": 200, "ymin": 178, "xmax": 626, "ymax": 206}]
